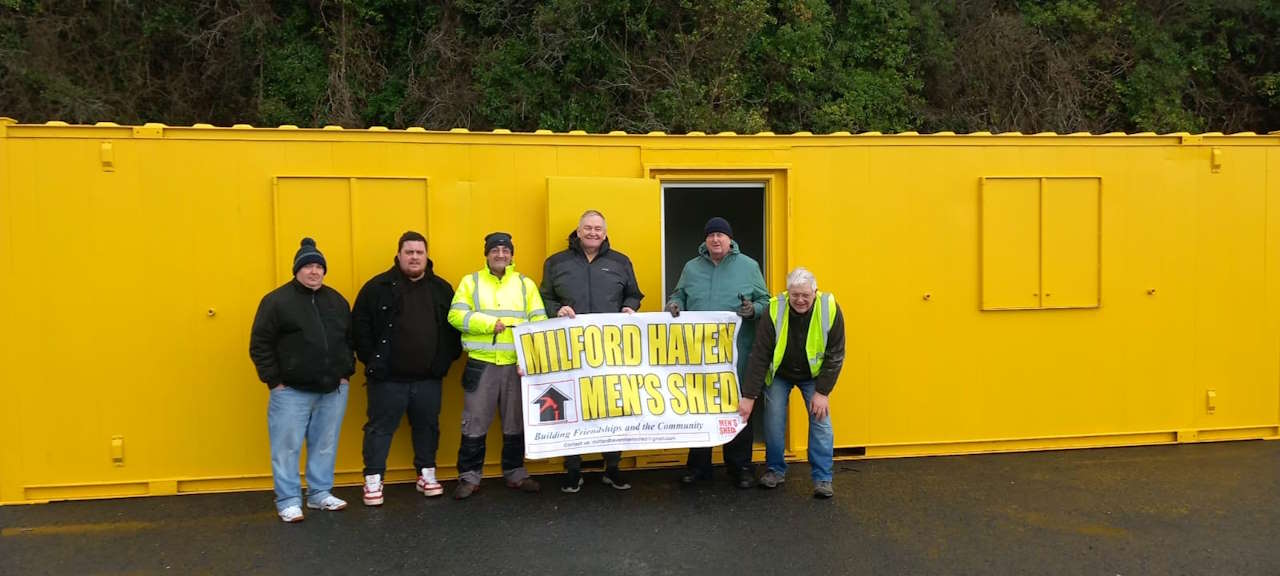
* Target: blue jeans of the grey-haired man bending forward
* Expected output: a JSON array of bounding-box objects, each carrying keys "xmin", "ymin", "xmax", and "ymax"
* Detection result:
[{"xmin": 764, "ymin": 378, "xmax": 836, "ymax": 483}]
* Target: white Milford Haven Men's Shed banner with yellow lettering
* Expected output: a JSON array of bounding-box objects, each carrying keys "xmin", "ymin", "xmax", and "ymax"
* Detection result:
[{"xmin": 512, "ymin": 312, "xmax": 745, "ymax": 458}]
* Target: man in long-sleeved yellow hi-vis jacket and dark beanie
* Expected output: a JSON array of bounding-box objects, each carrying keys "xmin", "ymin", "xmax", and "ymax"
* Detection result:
[{"xmin": 449, "ymin": 232, "xmax": 547, "ymax": 500}]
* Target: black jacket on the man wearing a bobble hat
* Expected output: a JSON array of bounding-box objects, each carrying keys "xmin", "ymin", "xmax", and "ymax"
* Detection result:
[{"xmin": 248, "ymin": 279, "xmax": 356, "ymax": 393}]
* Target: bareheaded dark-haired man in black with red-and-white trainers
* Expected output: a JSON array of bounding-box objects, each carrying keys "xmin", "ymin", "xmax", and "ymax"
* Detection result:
[{"xmin": 352, "ymin": 230, "xmax": 462, "ymax": 506}]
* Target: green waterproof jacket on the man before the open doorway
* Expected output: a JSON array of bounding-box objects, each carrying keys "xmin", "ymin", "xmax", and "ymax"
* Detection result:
[{"xmin": 667, "ymin": 242, "xmax": 769, "ymax": 375}]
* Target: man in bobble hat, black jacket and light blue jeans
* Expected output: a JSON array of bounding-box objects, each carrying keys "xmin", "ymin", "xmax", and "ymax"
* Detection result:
[{"xmin": 248, "ymin": 238, "xmax": 356, "ymax": 522}]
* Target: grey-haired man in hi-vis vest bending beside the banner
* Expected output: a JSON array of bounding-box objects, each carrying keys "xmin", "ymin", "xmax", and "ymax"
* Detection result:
[{"xmin": 739, "ymin": 268, "xmax": 845, "ymax": 498}]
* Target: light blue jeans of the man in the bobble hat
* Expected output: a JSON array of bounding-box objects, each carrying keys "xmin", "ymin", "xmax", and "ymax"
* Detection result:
[{"xmin": 266, "ymin": 384, "xmax": 347, "ymax": 511}]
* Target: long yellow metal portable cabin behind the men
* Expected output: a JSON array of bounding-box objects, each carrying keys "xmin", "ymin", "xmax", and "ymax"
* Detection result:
[{"xmin": 0, "ymin": 119, "xmax": 1280, "ymax": 503}]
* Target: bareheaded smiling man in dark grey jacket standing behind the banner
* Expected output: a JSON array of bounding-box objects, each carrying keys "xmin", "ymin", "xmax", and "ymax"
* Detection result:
[{"xmin": 539, "ymin": 210, "xmax": 644, "ymax": 493}]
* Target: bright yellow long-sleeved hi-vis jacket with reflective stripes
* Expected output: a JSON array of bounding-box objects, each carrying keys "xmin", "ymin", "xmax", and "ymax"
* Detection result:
[{"xmin": 449, "ymin": 266, "xmax": 547, "ymax": 366}]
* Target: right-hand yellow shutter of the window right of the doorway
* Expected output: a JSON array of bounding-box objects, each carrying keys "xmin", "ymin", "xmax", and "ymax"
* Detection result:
[{"xmin": 1041, "ymin": 178, "xmax": 1101, "ymax": 308}]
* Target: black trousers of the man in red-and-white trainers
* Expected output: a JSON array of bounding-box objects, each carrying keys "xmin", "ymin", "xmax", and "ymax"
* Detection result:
[{"xmin": 364, "ymin": 380, "xmax": 440, "ymax": 476}]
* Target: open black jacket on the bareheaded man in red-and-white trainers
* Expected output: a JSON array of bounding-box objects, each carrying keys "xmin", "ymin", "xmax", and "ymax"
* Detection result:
[{"xmin": 351, "ymin": 260, "xmax": 462, "ymax": 381}]
